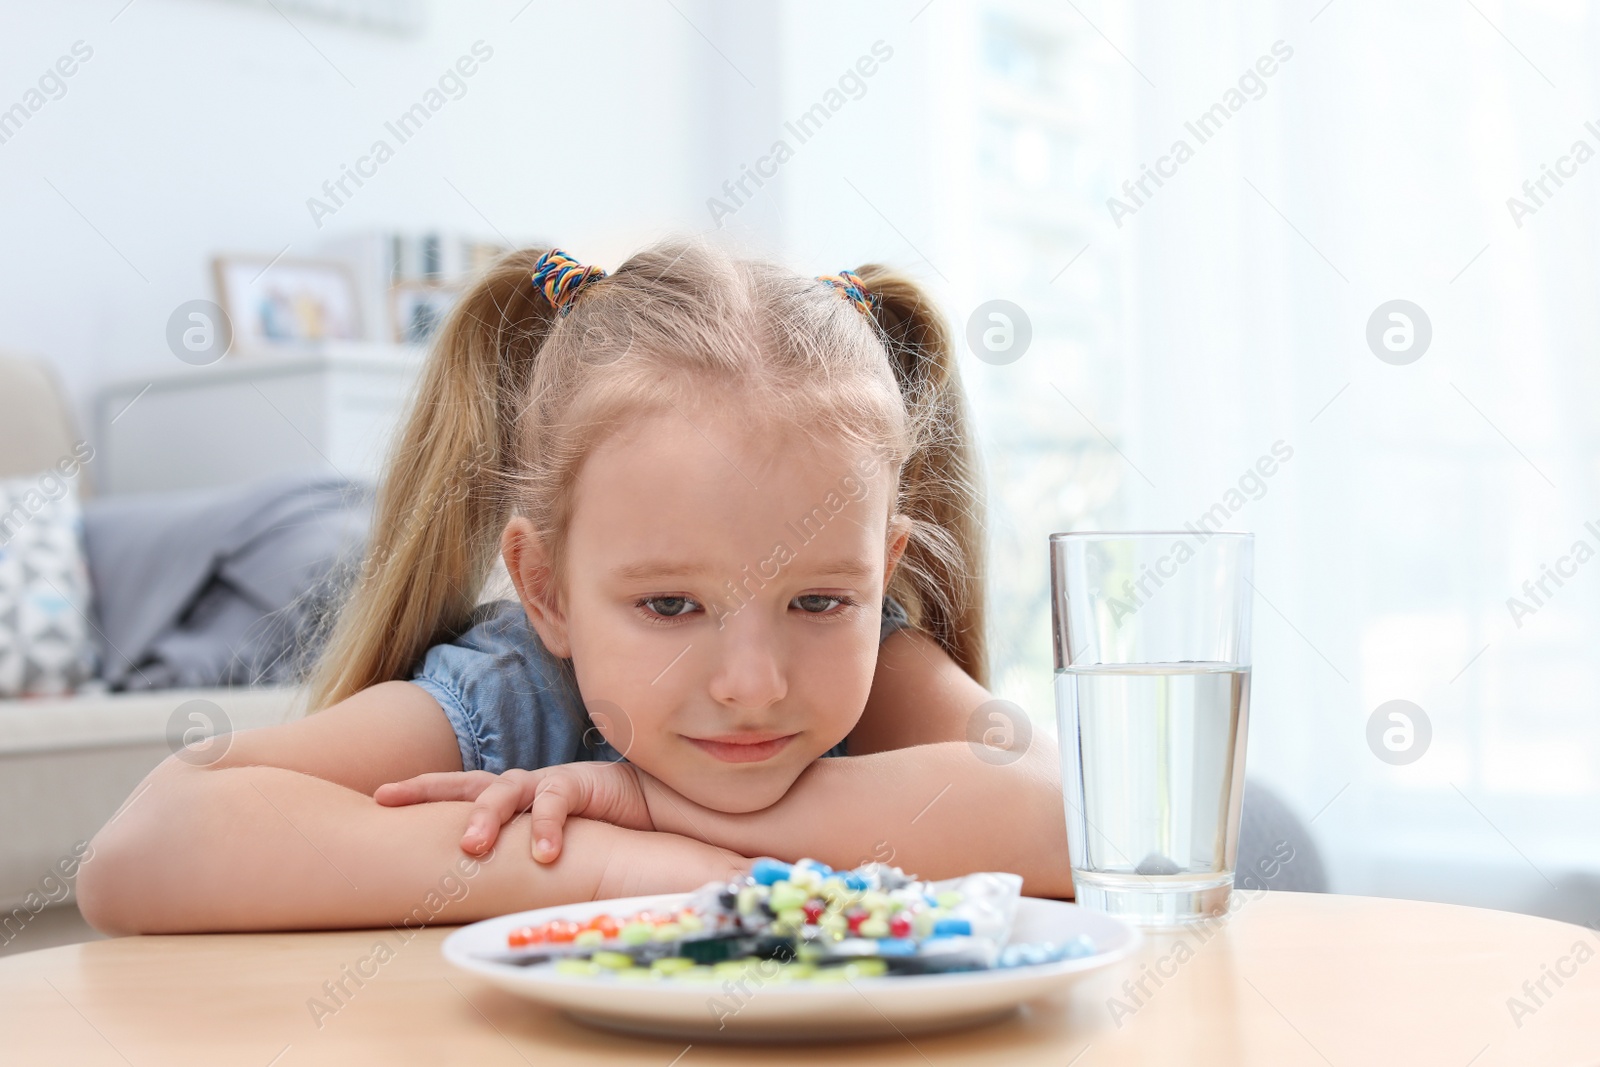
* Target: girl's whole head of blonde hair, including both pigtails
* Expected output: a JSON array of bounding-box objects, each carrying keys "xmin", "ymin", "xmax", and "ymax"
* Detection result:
[{"xmin": 310, "ymin": 240, "xmax": 987, "ymax": 709}]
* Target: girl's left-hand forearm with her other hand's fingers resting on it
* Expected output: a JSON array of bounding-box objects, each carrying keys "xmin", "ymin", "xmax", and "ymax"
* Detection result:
[{"xmin": 77, "ymin": 765, "xmax": 741, "ymax": 934}]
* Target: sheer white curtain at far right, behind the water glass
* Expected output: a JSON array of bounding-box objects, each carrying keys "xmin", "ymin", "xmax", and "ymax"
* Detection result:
[{"xmin": 1120, "ymin": 0, "xmax": 1600, "ymax": 921}]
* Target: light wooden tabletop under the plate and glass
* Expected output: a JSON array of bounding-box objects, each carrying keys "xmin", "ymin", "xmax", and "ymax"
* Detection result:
[{"xmin": 0, "ymin": 893, "xmax": 1600, "ymax": 1067}]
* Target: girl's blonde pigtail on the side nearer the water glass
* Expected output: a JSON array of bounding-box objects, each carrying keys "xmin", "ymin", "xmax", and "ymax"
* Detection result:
[{"xmin": 856, "ymin": 264, "xmax": 989, "ymax": 685}]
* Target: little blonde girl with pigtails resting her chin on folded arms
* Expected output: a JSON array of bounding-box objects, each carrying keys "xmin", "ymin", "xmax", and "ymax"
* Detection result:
[{"xmin": 78, "ymin": 242, "xmax": 1072, "ymax": 933}]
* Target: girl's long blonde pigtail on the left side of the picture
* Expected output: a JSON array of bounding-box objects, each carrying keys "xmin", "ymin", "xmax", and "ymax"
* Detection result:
[{"xmin": 309, "ymin": 248, "xmax": 555, "ymax": 710}]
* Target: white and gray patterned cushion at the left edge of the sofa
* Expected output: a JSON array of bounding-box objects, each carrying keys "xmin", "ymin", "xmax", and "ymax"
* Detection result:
[{"xmin": 0, "ymin": 470, "xmax": 94, "ymax": 697}]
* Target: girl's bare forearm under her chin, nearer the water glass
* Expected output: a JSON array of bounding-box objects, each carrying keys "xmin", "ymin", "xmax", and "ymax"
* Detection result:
[{"xmin": 646, "ymin": 741, "xmax": 1072, "ymax": 897}]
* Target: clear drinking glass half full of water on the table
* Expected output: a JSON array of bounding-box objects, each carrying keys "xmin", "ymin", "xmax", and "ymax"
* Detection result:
[{"xmin": 1050, "ymin": 530, "xmax": 1254, "ymax": 926}]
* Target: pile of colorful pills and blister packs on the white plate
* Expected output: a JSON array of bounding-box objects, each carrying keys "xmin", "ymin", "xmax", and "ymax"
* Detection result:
[{"xmin": 492, "ymin": 859, "xmax": 1094, "ymax": 982}]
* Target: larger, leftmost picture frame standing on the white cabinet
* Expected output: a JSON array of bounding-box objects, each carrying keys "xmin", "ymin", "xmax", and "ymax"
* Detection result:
[{"xmin": 211, "ymin": 254, "xmax": 365, "ymax": 350}]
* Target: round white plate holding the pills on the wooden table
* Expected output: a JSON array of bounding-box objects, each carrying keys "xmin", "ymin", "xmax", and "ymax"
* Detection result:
[{"xmin": 443, "ymin": 893, "xmax": 1141, "ymax": 1041}]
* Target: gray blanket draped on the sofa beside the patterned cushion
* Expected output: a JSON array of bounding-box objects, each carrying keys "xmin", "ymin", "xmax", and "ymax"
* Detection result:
[{"xmin": 83, "ymin": 475, "xmax": 371, "ymax": 689}]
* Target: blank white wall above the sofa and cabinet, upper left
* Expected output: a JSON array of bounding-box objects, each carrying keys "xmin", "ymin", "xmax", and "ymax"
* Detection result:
[{"xmin": 0, "ymin": 0, "xmax": 720, "ymax": 425}]
